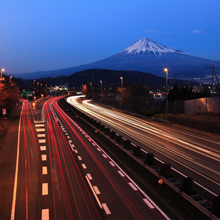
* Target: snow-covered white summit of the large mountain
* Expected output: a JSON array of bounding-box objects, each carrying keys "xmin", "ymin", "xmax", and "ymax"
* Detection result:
[{"xmin": 121, "ymin": 38, "xmax": 176, "ymax": 56}]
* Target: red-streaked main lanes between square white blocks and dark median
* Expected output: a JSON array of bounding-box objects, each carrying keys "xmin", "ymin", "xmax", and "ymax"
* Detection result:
[{"xmin": 44, "ymin": 99, "xmax": 169, "ymax": 219}]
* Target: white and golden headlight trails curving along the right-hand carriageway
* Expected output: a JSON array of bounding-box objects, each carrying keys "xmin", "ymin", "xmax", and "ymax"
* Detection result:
[{"xmin": 67, "ymin": 96, "xmax": 220, "ymax": 193}]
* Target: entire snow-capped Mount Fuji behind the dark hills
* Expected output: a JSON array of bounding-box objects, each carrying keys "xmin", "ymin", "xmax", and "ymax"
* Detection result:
[{"xmin": 15, "ymin": 38, "xmax": 220, "ymax": 82}]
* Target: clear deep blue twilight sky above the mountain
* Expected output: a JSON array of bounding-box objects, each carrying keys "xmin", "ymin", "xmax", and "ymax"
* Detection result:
[{"xmin": 0, "ymin": 0, "xmax": 220, "ymax": 75}]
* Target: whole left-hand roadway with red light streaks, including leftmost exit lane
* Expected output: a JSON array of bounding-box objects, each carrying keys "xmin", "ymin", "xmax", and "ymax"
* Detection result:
[{"xmin": 0, "ymin": 98, "xmax": 169, "ymax": 220}]
